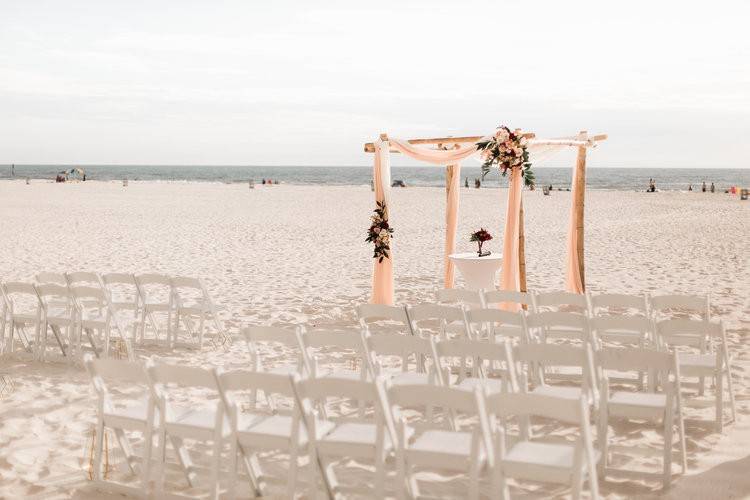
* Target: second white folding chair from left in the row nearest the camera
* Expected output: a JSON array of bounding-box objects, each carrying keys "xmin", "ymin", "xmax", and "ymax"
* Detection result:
[{"xmin": 144, "ymin": 361, "xmax": 231, "ymax": 499}]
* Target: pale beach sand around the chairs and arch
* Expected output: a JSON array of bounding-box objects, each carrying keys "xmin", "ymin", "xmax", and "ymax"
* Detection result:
[{"xmin": 0, "ymin": 181, "xmax": 750, "ymax": 498}]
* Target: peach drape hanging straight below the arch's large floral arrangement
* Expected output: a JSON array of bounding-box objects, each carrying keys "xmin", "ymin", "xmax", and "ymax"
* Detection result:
[{"xmin": 500, "ymin": 170, "xmax": 523, "ymax": 311}]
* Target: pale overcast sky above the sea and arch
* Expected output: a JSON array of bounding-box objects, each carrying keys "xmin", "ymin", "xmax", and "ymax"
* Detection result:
[{"xmin": 0, "ymin": 0, "xmax": 750, "ymax": 168}]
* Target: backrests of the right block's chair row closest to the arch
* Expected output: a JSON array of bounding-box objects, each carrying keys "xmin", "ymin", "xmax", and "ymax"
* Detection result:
[{"xmin": 436, "ymin": 288, "xmax": 711, "ymax": 321}]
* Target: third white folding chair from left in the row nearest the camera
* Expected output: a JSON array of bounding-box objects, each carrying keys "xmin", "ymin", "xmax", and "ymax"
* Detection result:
[{"xmin": 218, "ymin": 370, "xmax": 316, "ymax": 498}]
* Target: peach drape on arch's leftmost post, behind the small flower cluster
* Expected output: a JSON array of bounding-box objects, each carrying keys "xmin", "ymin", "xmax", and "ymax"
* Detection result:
[{"xmin": 371, "ymin": 140, "xmax": 393, "ymax": 305}]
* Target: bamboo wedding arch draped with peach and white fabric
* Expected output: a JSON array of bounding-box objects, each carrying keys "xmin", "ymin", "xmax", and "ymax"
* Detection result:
[{"xmin": 365, "ymin": 130, "xmax": 607, "ymax": 304}]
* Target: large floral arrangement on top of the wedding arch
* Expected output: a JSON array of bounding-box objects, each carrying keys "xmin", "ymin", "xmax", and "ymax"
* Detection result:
[{"xmin": 477, "ymin": 125, "xmax": 534, "ymax": 186}]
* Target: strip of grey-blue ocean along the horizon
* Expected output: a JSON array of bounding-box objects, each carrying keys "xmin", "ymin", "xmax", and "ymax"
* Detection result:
[{"xmin": 0, "ymin": 165, "xmax": 750, "ymax": 191}]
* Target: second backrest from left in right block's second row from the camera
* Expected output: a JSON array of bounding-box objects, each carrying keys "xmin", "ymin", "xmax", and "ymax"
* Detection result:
[{"xmin": 298, "ymin": 327, "xmax": 367, "ymax": 376}]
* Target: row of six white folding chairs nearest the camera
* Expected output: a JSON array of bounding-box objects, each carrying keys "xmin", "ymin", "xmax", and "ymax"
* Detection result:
[{"xmin": 86, "ymin": 346, "xmax": 598, "ymax": 498}]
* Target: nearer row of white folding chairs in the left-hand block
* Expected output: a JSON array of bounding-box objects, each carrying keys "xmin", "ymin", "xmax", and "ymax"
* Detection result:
[{"xmin": 0, "ymin": 282, "xmax": 133, "ymax": 362}]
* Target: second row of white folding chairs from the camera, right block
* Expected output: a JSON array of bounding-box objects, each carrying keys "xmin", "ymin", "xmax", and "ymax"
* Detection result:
[{"xmin": 243, "ymin": 324, "xmax": 686, "ymax": 486}]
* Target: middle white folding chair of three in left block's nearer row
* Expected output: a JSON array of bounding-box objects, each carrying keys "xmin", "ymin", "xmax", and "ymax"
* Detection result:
[{"xmin": 34, "ymin": 284, "xmax": 78, "ymax": 363}]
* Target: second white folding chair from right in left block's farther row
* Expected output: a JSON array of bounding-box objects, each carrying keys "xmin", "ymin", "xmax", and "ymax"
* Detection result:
[{"xmin": 135, "ymin": 274, "xmax": 174, "ymax": 347}]
